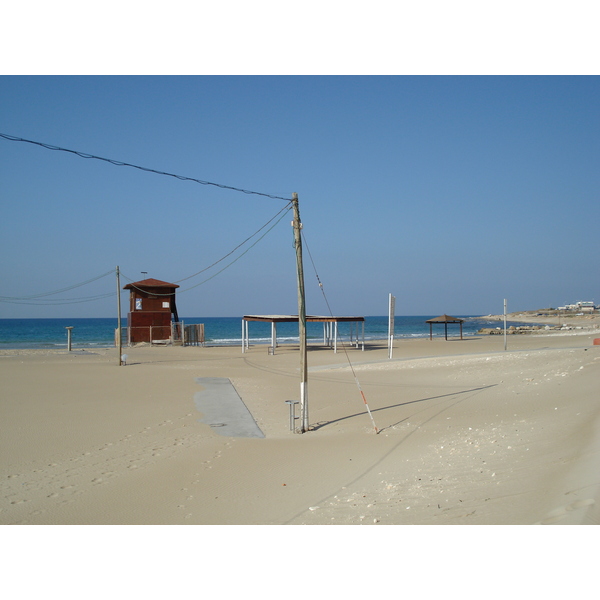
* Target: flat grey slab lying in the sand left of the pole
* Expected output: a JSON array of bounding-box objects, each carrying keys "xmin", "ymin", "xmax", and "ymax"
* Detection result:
[{"xmin": 194, "ymin": 377, "xmax": 265, "ymax": 438}]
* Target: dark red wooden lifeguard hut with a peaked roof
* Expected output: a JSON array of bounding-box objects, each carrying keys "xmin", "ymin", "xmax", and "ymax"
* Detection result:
[{"xmin": 123, "ymin": 279, "xmax": 179, "ymax": 344}]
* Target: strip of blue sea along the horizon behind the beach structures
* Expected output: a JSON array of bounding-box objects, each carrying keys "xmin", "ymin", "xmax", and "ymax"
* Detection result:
[{"xmin": 0, "ymin": 315, "xmax": 522, "ymax": 350}]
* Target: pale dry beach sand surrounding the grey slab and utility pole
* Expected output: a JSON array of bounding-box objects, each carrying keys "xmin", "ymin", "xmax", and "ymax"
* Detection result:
[{"xmin": 0, "ymin": 323, "xmax": 600, "ymax": 526}]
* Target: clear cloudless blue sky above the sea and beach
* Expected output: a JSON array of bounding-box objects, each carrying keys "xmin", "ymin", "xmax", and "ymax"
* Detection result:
[{"xmin": 0, "ymin": 76, "xmax": 600, "ymax": 318}]
